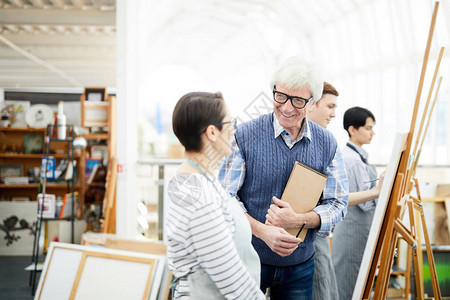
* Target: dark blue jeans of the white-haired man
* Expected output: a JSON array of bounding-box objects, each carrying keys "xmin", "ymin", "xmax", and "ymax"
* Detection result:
[{"xmin": 260, "ymin": 256, "xmax": 314, "ymax": 300}]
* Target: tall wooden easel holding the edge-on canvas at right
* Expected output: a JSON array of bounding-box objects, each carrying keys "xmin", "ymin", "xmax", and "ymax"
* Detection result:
[{"xmin": 362, "ymin": 2, "xmax": 444, "ymax": 299}]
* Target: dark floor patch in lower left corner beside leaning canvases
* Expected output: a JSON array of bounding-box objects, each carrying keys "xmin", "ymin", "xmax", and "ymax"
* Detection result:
[{"xmin": 0, "ymin": 256, "xmax": 40, "ymax": 300}]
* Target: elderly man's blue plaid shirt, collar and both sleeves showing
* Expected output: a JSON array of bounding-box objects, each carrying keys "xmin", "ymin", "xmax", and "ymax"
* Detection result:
[{"xmin": 219, "ymin": 116, "xmax": 348, "ymax": 236}]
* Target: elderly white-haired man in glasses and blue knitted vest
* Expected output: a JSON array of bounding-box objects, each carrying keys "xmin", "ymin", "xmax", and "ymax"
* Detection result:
[{"xmin": 219, "ymin": 57, "xmax": 348, "ymax": 300}]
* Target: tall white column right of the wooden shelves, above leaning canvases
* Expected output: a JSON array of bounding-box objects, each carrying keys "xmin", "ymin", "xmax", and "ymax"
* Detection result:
[{"xmin": 116, "ymin": 0, "xmax": 139, "ymax": 238}]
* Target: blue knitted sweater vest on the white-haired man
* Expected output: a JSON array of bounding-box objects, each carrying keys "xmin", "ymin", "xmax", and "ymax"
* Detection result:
[{"xmin": 236, "ymin": 114, "xmax": 337, "ymax": 266}]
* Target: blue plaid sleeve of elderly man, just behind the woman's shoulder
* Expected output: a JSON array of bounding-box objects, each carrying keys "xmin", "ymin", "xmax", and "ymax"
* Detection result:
[{"xmin": 218, "ymin": 137, "xmax": 247, "ymax": 212}]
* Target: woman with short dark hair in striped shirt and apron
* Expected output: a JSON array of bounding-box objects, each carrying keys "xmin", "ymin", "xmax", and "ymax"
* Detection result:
[{"xmin": 166, "ymin": 92, "xmax": 265, "ymax": 299}]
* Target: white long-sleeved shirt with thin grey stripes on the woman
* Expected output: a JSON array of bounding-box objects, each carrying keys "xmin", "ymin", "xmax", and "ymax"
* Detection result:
[{"xmin": 166, "ymin": 174, "xmax": 264, "ymax": 299}]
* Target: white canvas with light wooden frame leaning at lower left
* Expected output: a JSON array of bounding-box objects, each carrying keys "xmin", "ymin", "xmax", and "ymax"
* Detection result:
[{"xmin": 35, "ymin": 243, "xmax": 166, "ymax": 300}]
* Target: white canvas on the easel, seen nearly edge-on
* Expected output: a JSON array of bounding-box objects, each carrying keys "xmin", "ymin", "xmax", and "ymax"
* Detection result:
[{"xmin": 352, "ymin": 133, "xmax": 407, "ymax": 300}]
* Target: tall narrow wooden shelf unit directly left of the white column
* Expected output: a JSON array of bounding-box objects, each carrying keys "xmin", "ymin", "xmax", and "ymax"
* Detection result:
[{"xmin": 80, "ymin": 88, "xmax": 116, "ymax": 231}]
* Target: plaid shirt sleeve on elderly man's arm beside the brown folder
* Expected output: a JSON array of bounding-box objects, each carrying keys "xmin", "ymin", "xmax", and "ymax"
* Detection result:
[{"xmin": 314, "ymin": 148, "xmax": 348, "ymax": 236}]
